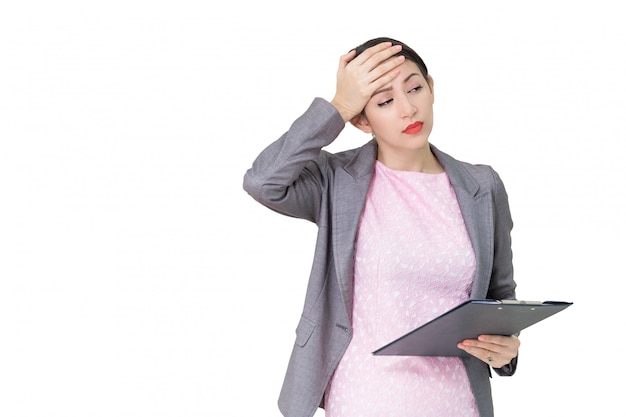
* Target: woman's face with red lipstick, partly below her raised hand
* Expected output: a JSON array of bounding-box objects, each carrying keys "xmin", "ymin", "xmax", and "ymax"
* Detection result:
[{"xmin": 357, "ymin": 60, "xmax": 435, "ymax": 153}]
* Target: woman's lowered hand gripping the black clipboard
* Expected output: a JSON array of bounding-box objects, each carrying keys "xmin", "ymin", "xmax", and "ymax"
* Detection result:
[{"xmin": 457, "ymin": 335, "xmax": 520, "ymax": 368}]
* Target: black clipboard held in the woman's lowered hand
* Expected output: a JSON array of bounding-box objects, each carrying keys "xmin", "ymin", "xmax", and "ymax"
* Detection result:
[{"xmin": 372, "ymin": 300, "xmax": 573, "ymax": 356}]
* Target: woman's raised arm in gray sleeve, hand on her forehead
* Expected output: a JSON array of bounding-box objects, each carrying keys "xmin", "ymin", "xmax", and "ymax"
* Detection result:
[{"xmin": 244, "ymin": 42, "xmax": 404, "ymax": 221}]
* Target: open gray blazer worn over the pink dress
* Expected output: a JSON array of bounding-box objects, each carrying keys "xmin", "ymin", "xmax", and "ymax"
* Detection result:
[{"xmin": 243, "ymin": 98, "xmax": 517, "ymax": 417}]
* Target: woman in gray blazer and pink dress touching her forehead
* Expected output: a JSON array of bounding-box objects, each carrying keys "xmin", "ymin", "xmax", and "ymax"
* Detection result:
[{"xmin": 244, "ymin": 38, "xmax": 519, "ymax": 417}]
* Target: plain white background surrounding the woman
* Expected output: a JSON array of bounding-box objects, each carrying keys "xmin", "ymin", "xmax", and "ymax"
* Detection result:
[{"xmin": 0, "ymin": 0, "xmax": 626, "ymax": 417}]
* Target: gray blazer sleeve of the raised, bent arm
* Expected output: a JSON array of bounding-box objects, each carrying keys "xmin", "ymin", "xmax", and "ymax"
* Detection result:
[{"xmin": 243, "ymin": 98, "xmax": 345, "ymax": 222}]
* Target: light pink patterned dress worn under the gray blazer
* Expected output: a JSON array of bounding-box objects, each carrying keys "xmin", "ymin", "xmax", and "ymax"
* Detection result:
[{"xmin": 325, "ymin": 162, "xmax": 478, "ymax": 417}]
